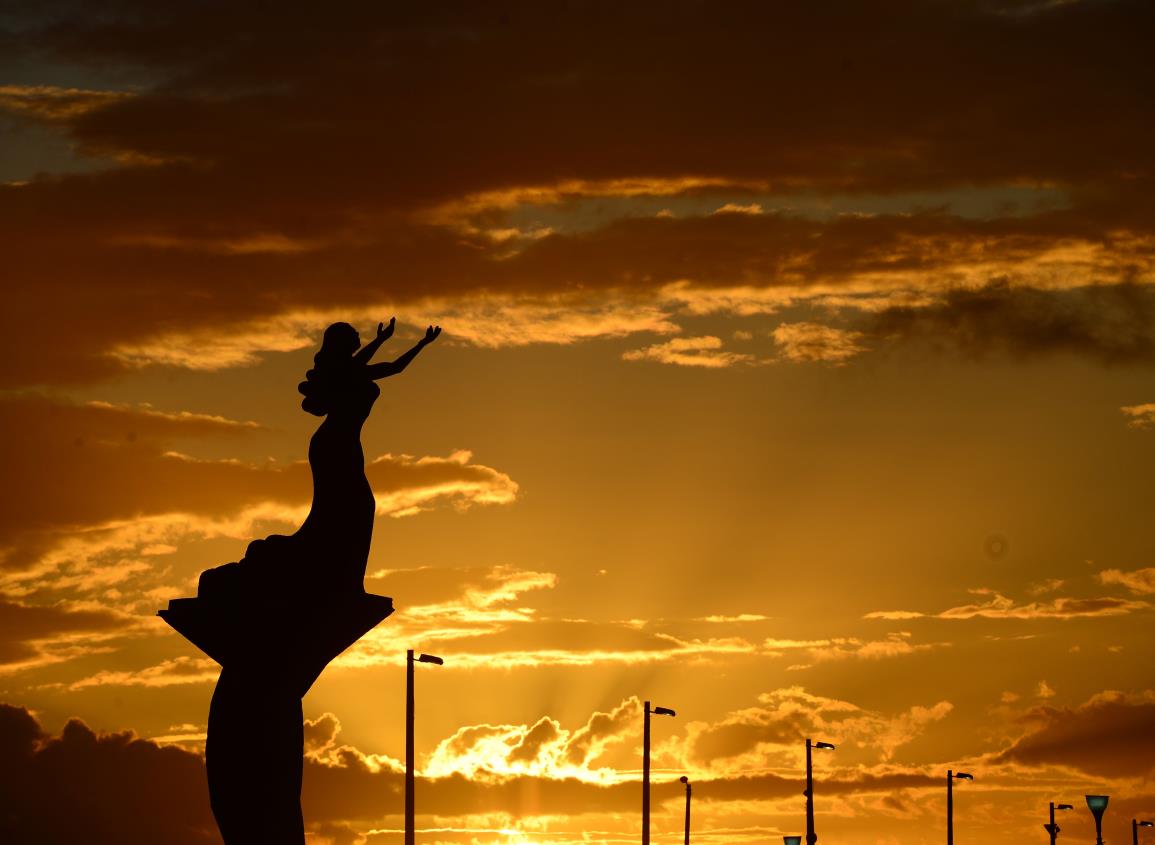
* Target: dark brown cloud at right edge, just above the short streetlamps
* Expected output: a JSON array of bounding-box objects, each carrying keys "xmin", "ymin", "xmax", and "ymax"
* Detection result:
[{"xmin": 994, "ymin": 693, "xmax": 1155, "ymax": 777}]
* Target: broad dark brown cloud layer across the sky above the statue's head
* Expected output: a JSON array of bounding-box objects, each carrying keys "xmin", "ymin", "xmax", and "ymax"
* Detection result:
[{"xmin": 0, "ymin": 0, "xmax": 1155, "ymax": 386}]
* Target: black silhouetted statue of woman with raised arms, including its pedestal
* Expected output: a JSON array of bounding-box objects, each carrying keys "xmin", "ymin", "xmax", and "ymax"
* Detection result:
[{"xmin": 161, "ymin": 320, "xmax": 441, "ymax": 845}]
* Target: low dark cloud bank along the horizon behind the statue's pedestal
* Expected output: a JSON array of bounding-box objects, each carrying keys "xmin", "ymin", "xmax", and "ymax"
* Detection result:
[{"xmin": 0, "ymin": 705, "xmax": 938, "ymax": 845}]
